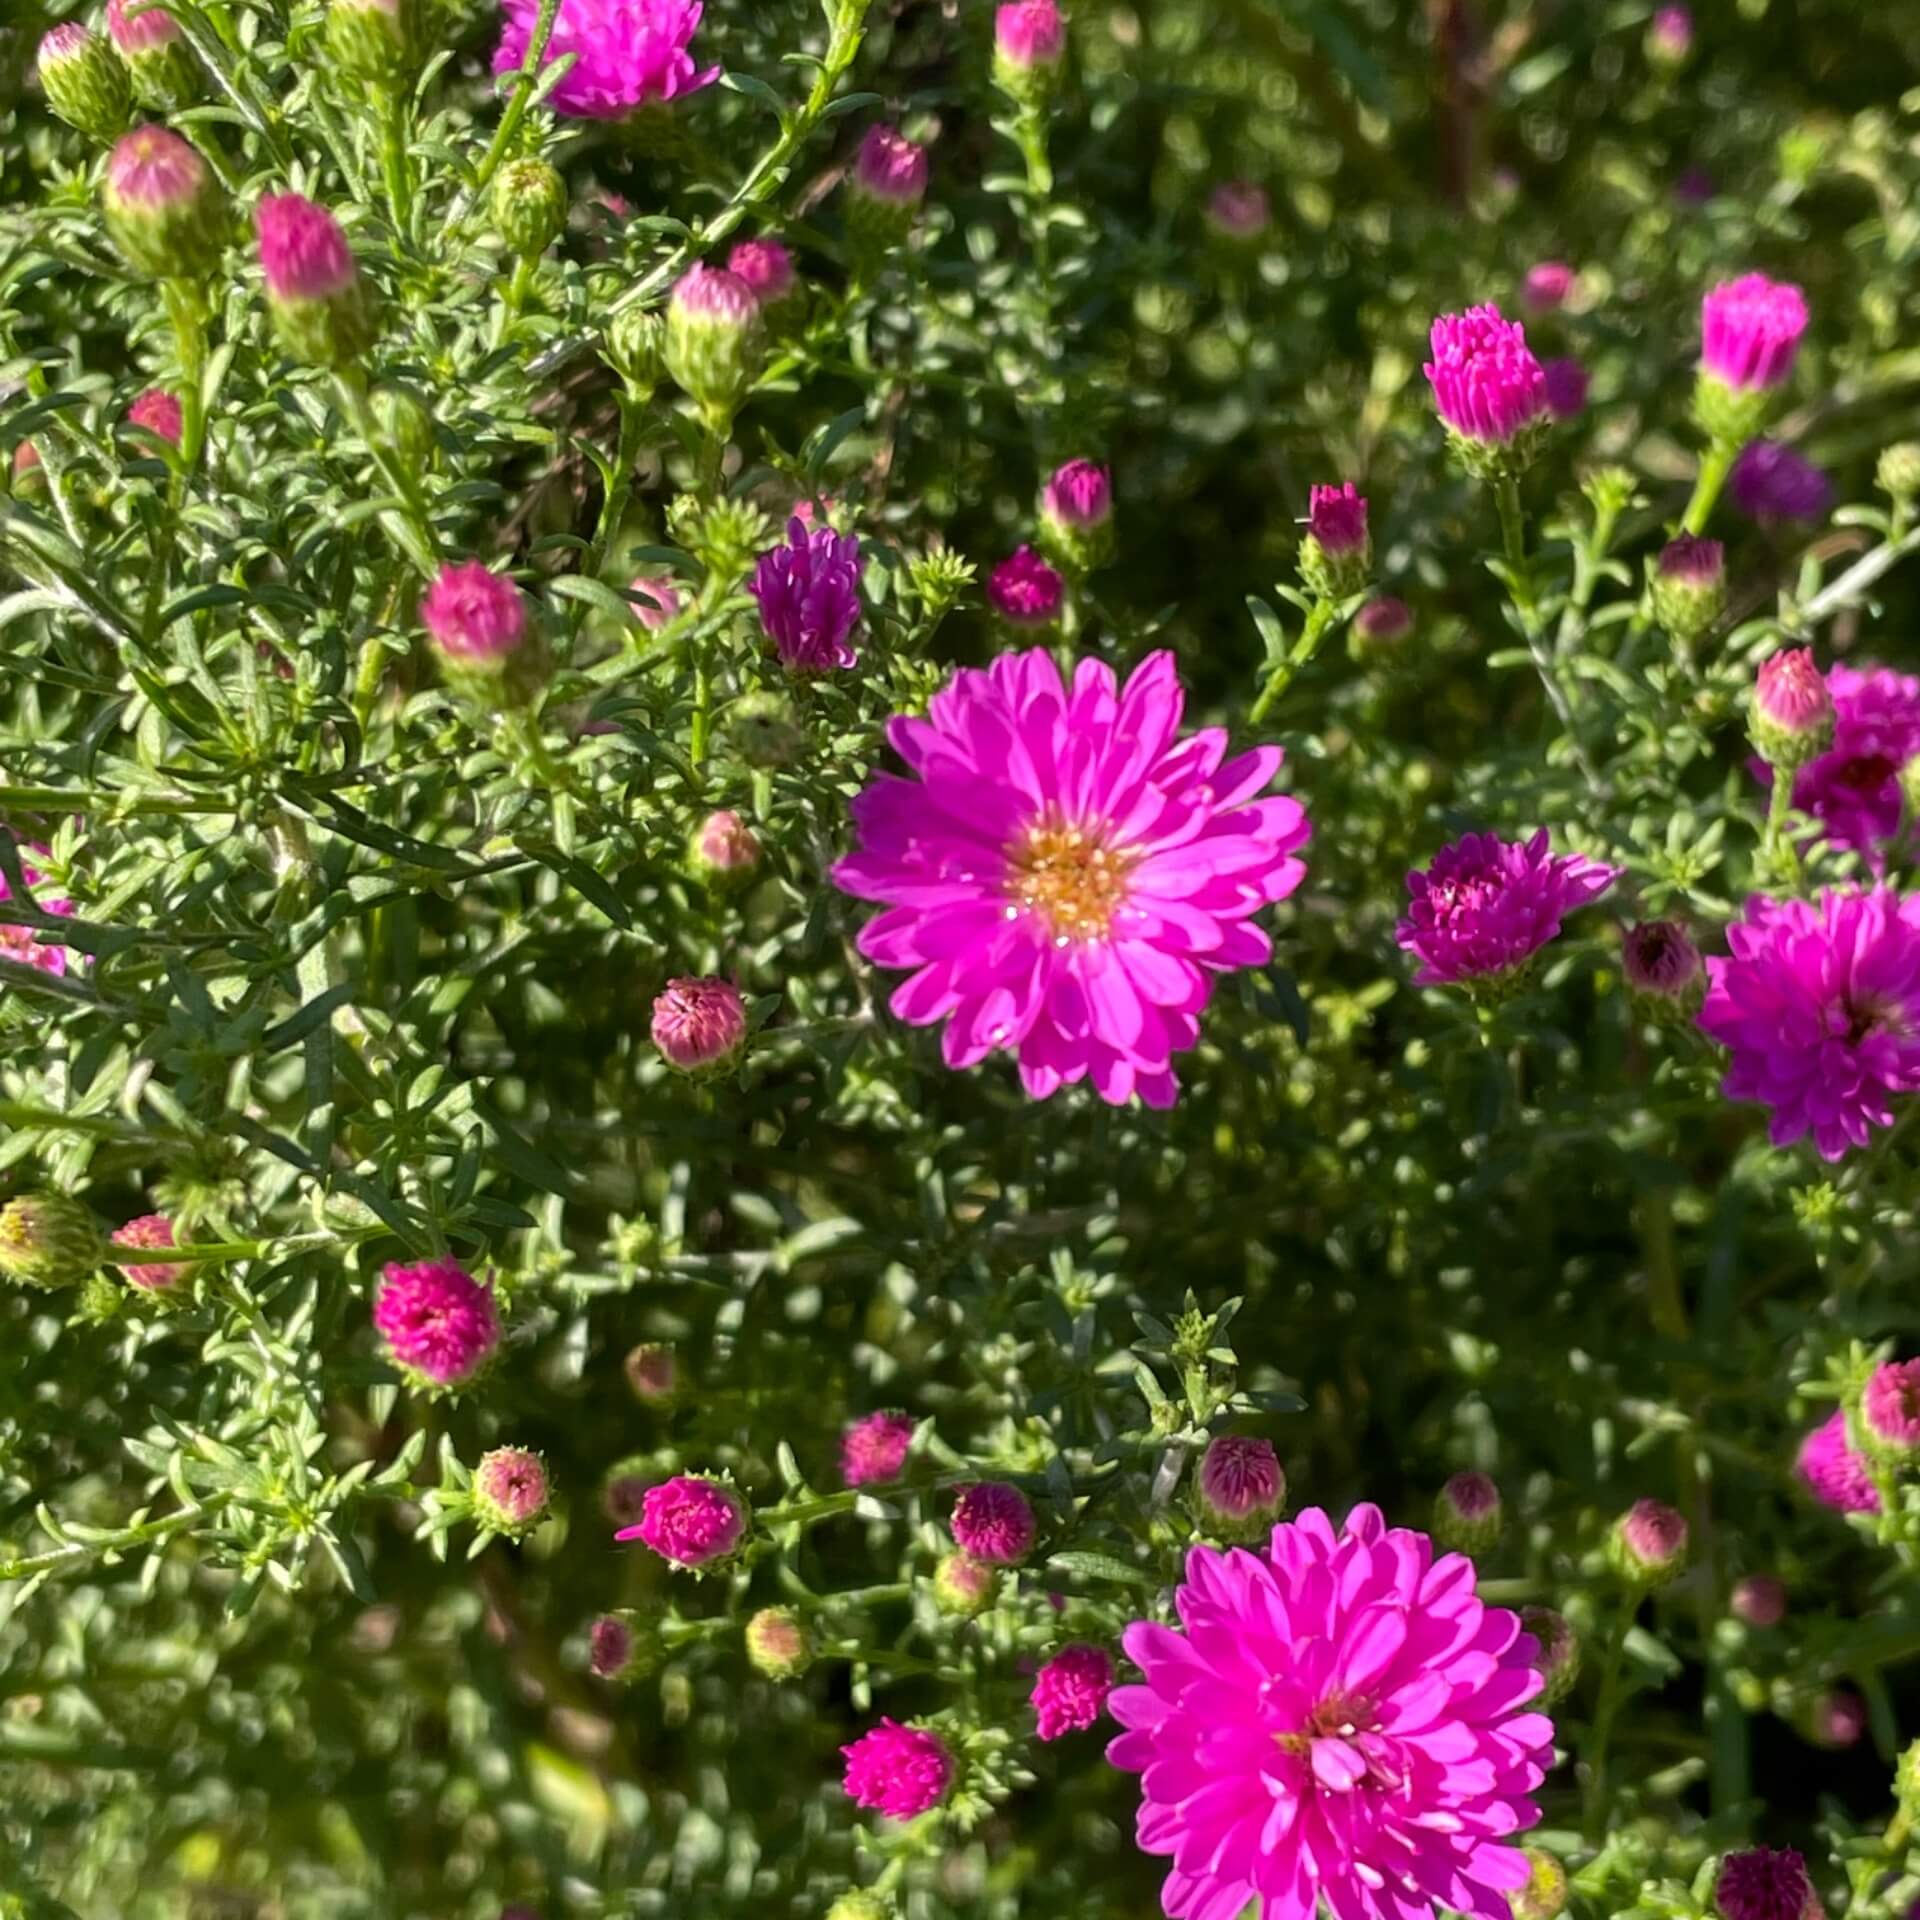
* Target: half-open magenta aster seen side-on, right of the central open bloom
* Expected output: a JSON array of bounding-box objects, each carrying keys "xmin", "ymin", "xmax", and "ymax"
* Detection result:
[{"xmin": 1394, "ymin": 828, "xmax": 1620, "ymax": 987}]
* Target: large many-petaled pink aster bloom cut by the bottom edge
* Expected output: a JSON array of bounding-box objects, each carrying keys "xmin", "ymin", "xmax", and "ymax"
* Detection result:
[{"xmin": 1108, "ymin": 1505, "xmax": 1553, "ymax": 1920}]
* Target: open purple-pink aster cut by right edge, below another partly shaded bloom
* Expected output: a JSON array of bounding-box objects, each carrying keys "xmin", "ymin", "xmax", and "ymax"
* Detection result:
[{"xmin": 1699, "ymin": 887, "xmax": 1920, "ymax": 1160}]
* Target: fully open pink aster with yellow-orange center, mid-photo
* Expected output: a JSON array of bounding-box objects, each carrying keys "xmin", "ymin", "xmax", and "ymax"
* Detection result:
[{"xmin": 833, "ymin": 647, "xmax": 1308, "ymax": 1106}]
